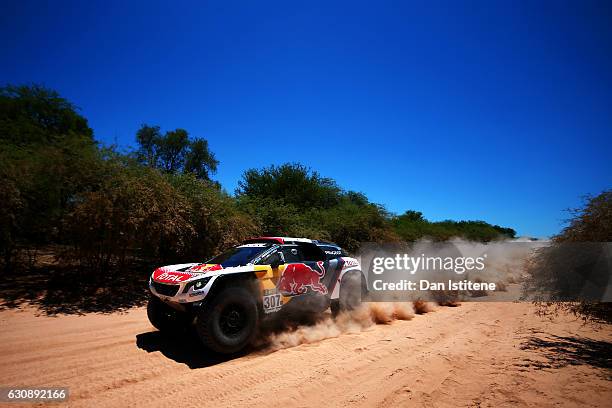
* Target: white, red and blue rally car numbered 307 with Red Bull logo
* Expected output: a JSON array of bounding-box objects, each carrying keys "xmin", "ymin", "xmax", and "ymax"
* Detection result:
[{"xmin": 147, "ymin": 237, "xmax": 367, "ymax": 353}]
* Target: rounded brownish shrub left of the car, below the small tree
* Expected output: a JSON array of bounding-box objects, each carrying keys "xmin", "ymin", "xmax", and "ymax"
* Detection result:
[{"xmin": 64, "ymin": 159, "xmax": 195, "ymax": 270}]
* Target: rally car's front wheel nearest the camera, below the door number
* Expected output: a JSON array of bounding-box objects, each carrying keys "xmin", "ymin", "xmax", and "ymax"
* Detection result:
[{"xmin": 196, "ymin": 287, "xmax": 259, "ymax": 354}]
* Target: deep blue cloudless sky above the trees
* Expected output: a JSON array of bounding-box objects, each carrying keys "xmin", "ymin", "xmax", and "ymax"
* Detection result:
[{"xmin": 0, "ymin": 1, "xmax": 612, "ymax": 236}]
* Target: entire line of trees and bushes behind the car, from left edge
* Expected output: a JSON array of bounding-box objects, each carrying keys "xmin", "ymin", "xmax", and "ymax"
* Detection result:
[{"xmin": 0, "ymin": 85, "xmax": 514, "ymax": 280}]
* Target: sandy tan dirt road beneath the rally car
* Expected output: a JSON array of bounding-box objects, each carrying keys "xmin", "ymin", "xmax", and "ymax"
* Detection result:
[{"xmin": 0, "ymin": 303, "xmax": 612, "ymax": 407}]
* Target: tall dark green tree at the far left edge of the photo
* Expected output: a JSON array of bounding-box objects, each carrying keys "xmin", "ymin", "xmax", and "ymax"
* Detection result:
[{"xmin": 0, "ymin": 85, "xmax": 100, "ymax": 270}]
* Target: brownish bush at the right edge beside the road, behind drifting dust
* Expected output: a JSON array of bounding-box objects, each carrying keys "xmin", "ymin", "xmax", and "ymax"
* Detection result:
[{"xmin": 523, "ymin": 190, "xmax": 612, "ymax": 323}]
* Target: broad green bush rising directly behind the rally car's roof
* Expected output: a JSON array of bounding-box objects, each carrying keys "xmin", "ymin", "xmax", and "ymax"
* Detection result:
[{"xmin": 236, "ymin": 164, "xmax": 398, "ymax": 251}]
